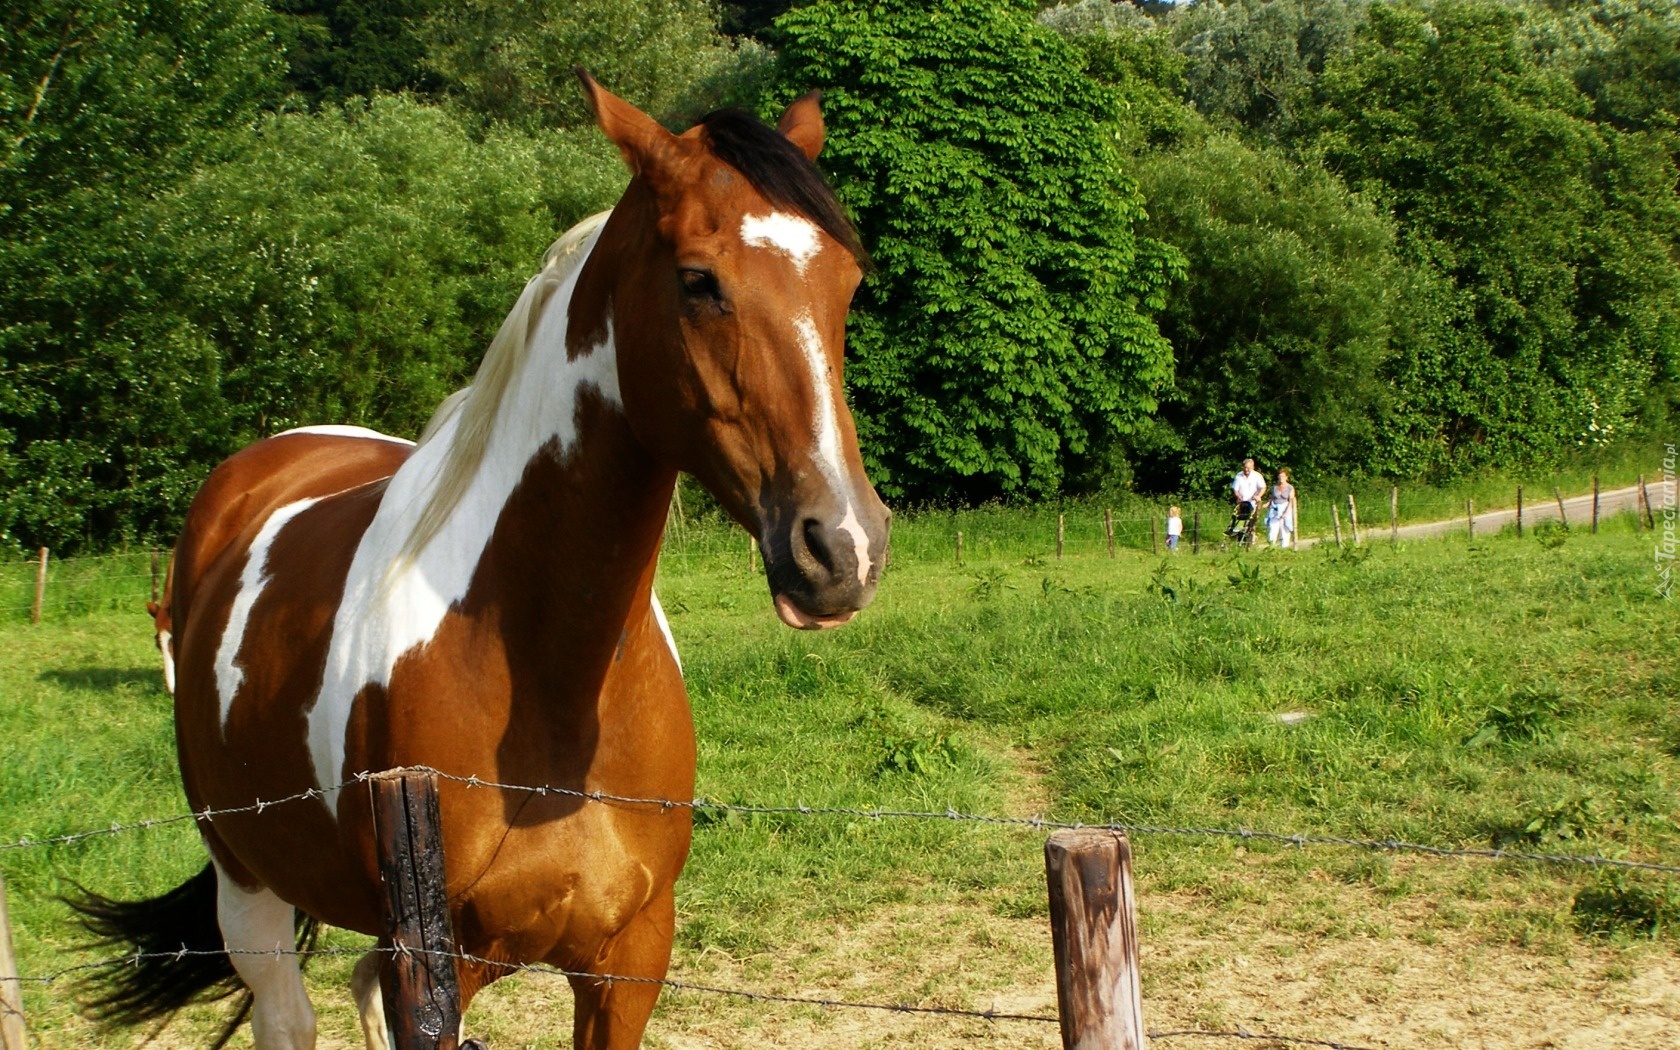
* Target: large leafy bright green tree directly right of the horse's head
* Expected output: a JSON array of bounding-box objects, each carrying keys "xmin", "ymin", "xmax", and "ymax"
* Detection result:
[{"xmin": 771, "ymin": 0, "xmax": 1178, "ymax": 499}]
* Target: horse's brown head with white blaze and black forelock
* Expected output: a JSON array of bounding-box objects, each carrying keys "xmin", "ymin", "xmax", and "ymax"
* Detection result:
[{"xmin": 568, "ymin": 71, "xmax": 892, "ymax": 628}]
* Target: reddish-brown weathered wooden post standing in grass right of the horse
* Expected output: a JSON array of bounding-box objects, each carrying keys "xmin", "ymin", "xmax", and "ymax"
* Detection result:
[{"xmin": 1045, "ymin": 828, "xmax": 1144, "ymax": 1050}]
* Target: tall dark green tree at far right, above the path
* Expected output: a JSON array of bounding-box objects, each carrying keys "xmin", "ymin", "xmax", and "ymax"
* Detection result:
[{"xmin": 1317, "ymin": 0, "xmax": 1680, "ymax": 469}]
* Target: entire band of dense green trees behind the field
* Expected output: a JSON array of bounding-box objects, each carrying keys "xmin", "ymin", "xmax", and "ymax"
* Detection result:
[{"xmin": 0, "ymin": 0, "xmax": 1680, "ymax": 551}]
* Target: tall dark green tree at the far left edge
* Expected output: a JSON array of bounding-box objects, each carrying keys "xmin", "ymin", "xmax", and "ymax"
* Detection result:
[{"xmin": 0, "ymin": 0, "xmax": 281, "ymax": 549}]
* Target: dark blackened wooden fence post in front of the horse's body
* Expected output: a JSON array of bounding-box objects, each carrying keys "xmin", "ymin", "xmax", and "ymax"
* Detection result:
[{"xmin": 368, "ymin": 769, "xmax": 460, "ymax": 1050}]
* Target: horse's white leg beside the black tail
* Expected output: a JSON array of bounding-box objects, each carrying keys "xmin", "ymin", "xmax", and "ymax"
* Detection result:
[{"xmin": 215, "ymin": 864, "xmax": 314, "ymax": 1050}]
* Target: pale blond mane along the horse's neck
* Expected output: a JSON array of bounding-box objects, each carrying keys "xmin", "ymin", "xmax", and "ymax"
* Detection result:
[{"xmin": 391, "ymin": 210, "xmax": 612, "ymax": 573}]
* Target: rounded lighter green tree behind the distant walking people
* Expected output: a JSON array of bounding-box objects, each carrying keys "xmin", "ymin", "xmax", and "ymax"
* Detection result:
[{"xmin": 1132, "ymin": 134, "xmax": 1410, "ymax": 491}]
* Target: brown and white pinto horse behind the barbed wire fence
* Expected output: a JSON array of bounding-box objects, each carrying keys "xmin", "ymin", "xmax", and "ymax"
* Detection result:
[{"xmin": 82, "ymin": 74, "xmax": 889, "ymax": 1050}]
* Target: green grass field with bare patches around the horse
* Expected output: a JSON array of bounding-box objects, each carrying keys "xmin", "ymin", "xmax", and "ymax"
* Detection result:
[{"xmin": 0, "ymin": 493, "xmax": 1680, "ymax": 1050}]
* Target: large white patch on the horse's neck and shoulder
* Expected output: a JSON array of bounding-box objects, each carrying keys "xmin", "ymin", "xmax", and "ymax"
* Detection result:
[{"xmin": 307, "ymin": 223, "xmax": 623, "ymax": 813}]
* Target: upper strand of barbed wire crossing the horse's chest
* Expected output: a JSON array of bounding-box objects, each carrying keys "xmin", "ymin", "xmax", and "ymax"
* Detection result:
[{"xmin": 0, "ymin": 766, "xmax": 1680, "ymax": 874}]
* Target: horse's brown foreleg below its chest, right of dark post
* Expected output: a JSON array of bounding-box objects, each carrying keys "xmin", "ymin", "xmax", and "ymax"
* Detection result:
[{"xmin": 571, "ymin": 889, "xmax": 677, "ymax": 1050}]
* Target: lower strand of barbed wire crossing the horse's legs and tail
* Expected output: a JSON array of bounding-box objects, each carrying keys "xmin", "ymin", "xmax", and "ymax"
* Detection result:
[{"xmin": 0, "ymin": 944, "xmax": 1369, "ymax": 1050}]
